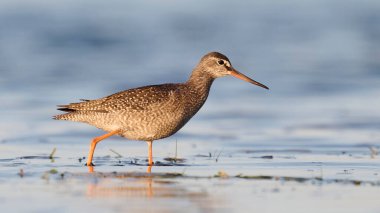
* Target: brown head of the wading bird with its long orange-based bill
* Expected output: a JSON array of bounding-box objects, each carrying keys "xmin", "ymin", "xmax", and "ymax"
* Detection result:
[{"xmin": 199, "ymin": 52, "xmax": 269, "ymax": 89}]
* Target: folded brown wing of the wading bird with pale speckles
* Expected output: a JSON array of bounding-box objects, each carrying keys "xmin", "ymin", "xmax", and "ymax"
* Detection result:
[{"xmin": 58, "ymin": 84, "xmax": 180, "ymax": 112}]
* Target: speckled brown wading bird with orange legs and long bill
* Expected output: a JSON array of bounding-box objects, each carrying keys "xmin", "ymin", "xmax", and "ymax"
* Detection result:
[{"xmin": 53, "ymin": 52, "xmax": 269, "ymax": 167}]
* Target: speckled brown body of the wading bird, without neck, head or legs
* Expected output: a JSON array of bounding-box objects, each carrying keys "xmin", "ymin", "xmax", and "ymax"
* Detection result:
[{"xmin": 55, "ymin": 84, "xmax": 208, "ymax": 141}]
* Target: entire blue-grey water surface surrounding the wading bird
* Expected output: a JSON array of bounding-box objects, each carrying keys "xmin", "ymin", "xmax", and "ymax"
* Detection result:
[{"xmin": 0, "ymin": 0, "xmax": 380, "ymax": 212}]
